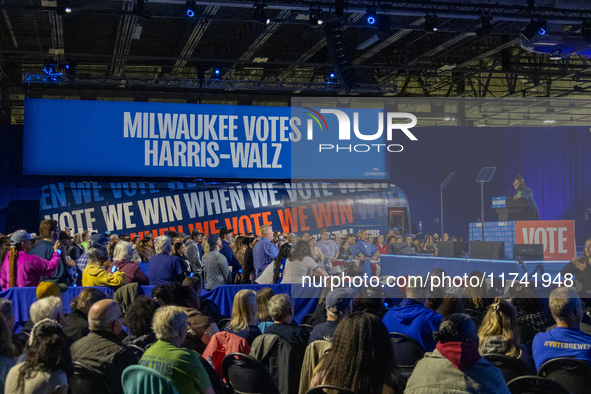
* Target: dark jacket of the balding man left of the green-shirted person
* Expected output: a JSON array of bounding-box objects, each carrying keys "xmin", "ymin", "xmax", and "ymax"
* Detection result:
[{"xmin": 70, "ymin": 331, "xmax": 139, "ymax": 394}]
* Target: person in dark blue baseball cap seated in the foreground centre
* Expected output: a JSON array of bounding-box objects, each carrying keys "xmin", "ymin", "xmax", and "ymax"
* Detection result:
[{"xmin": 308, "ymin": 289, "xmax": 353, "ymax": 343}]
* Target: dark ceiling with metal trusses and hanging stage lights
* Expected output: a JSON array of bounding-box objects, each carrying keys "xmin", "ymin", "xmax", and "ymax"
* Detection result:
[{"xmin": 0, "ymin": 0, "xmax": 591, "ymax": 123}]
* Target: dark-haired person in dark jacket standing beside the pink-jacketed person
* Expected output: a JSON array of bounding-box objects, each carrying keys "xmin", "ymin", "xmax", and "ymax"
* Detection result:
[{"xmin": 30, "ymin": 219, "xmax": 76, "ymax": 286}]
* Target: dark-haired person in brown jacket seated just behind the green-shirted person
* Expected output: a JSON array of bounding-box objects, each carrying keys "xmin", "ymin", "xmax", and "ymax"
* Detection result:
[{"xmin": 170, "ymin": 283, "xmax": 220, "ymax": 354}]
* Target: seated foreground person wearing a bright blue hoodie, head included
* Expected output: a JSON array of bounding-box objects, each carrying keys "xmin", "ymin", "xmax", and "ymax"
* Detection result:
[{"xmin": 382, "ymin": 278, "xmax": 442, "ymax": 352}]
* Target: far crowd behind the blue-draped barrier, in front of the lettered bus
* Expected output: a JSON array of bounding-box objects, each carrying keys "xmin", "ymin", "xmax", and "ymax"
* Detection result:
[{"xmin": 0, "ymin": 219, "xmax": 470, "ymax": 290}]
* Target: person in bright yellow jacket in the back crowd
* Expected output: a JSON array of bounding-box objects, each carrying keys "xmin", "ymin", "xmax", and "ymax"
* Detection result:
[{"xmin": 82, "ymin": 245, "xmax": 126, "ymax": 287}]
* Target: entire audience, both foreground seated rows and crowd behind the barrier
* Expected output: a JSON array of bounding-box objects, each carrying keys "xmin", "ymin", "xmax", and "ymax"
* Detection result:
[{"xmin": 0, "ymin": 220, "xmax": 591, "ymax": 394}]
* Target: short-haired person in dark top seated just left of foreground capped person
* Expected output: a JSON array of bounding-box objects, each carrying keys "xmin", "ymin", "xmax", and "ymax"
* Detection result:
[{"xmin": 265, "ymin": 292, "xmax": 310, "ymax": 345}]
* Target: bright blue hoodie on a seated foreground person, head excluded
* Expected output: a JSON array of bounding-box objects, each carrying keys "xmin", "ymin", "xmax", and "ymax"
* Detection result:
[{"xmin": 382, "ymin": 298, "xmax": 443, "ymax": 352}]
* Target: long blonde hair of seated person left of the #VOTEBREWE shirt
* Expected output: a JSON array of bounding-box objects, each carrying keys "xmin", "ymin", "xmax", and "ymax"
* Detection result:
[{"xmin": 478, "ymin": 298, "xmax": 521, "ymax": 358}]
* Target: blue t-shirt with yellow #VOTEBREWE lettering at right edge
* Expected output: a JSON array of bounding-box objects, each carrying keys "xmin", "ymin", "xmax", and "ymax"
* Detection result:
[{"xmin": 532, "ymin": 327, "xmax": 591, "ymax": 369}]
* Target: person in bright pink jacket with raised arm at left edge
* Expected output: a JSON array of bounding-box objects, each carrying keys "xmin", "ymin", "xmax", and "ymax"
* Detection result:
[{"xmin": 0, "ymin": 230, "xmax": 60, "ymax": 290}]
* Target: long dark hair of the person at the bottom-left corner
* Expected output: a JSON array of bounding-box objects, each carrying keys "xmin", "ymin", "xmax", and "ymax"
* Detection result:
[{"xmin": 17, "ymin": 319, "xmax": 72, "ymax": 391}]
